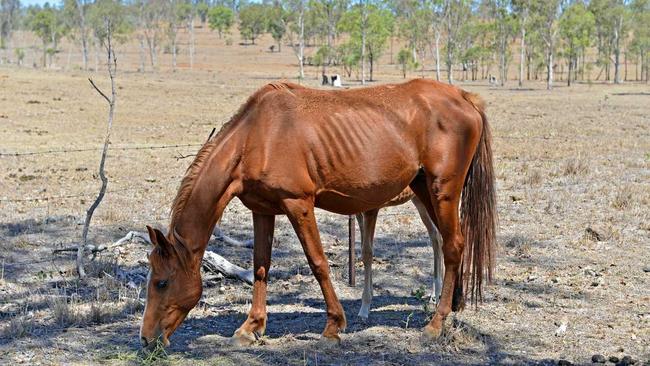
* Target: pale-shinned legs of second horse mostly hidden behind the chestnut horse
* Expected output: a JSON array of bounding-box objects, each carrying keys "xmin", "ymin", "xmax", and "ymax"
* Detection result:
[{"xmin": 356, "ymin": 188, "xmax": 444, "ymax": 320}]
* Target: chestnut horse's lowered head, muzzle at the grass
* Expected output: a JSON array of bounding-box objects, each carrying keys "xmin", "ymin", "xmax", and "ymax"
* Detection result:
[{"xmin": 140, "ymin": 226, "xmax": 202, "ymax": 347}]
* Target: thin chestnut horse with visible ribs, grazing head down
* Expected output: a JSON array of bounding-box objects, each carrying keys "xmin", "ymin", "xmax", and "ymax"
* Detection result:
[{"xmin": 140, "ymin": 79, "xmax": 496, "ymax": 345}]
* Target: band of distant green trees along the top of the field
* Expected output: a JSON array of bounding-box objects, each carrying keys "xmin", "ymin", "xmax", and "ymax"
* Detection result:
[{"xmin": 0, "ymin": 0, "xmax": 650, "ymax": 89}]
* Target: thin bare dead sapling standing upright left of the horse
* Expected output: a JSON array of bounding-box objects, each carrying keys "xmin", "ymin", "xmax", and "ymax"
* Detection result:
[{"xmin": 77, "ymin": 19, "xmax": 117, "ymax": 278}]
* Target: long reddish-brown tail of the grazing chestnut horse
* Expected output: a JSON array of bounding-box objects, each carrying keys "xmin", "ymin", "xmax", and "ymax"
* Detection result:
[{"xmin": 454, "ymin": 91, "xmax": 497, "ymax": 308}]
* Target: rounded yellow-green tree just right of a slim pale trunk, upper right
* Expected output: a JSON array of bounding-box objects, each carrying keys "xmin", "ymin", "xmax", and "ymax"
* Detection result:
[{"xmin": 559, "ymin": 2, "xmax": 595, "ymax": 86}]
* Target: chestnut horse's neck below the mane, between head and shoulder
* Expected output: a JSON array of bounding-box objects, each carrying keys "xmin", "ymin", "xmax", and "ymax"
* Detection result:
[{"xmin": 171, "ymin": 132, "xmax": 239, "ymax": 258}]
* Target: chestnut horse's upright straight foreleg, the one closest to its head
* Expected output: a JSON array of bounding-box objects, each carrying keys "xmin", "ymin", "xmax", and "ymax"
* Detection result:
[{"xmin": 233, "ymin": 213, "xmax": 275, "ymax": 345}]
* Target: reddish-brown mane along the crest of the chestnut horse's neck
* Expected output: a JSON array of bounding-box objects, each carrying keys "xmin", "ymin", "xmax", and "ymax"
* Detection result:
[{"xmin": 169, "ymin": 82, "xmax": 304, "ymax": 233}]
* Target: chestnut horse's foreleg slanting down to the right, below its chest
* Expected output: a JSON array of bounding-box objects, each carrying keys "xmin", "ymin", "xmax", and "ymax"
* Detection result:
[{"xmin": 282, "ymin": 199, "xmax": 346, "ymax": 342}]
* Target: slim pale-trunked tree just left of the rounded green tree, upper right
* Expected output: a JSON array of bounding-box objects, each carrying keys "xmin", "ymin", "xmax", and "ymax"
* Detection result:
[{"xmin": 531, "ymin": 0, "xmax": 560, "ymax": 90}]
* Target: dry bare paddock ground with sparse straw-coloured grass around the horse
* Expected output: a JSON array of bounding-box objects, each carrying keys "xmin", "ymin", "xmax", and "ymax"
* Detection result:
[{"xmin": 0, "ymin": 27, "xmax": 650, "ymax": 365}]
